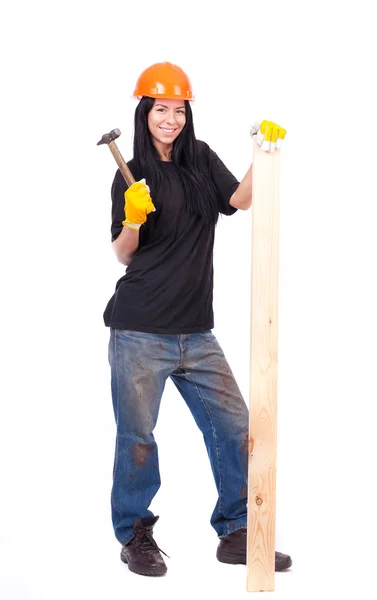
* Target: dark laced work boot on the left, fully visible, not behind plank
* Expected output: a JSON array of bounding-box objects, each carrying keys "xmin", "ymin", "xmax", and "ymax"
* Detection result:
[{"xmin": 120, "ymin": 517, "xmax": 169, "ymax": 575}]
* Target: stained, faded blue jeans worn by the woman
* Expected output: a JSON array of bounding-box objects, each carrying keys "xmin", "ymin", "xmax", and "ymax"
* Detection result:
[{"xmin": 109, "ymin": 328, "xmax": 249, "ymax": 544}]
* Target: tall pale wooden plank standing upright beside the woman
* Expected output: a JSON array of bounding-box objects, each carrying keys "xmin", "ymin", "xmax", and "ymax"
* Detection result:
[{"xmin": 246, "ymin": 136, "xmax": 280, "ymax": 592}]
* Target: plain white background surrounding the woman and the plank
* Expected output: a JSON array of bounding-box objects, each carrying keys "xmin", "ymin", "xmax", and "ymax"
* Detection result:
[{"xmin": 0, "ymin": 0, "xmax": 377, "ymax": 600}]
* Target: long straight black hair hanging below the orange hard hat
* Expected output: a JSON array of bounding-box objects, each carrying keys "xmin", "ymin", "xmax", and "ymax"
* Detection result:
[{"xmin": 133, "ymin": 96, "xmax": 219, "ymax": 225}]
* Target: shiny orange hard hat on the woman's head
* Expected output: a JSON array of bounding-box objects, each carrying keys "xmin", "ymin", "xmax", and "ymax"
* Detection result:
[{"xmin": 133, "ymin": 62, "xmax": 194, "ymax": 100}]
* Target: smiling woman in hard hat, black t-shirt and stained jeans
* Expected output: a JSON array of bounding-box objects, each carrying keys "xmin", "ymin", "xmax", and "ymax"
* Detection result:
[{"xmin": 104, "ymin": 63, "xmax": 291, "ymax": 575}]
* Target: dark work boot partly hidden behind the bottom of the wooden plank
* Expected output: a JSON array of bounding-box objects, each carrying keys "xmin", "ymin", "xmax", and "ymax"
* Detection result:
[{"xmin": 216, "ymin": 528, "xmax": 292, "ymax": 571}]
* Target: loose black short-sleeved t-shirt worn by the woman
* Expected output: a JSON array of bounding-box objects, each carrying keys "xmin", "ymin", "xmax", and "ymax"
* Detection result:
[{"xmin": 103, "ymin": 142, "xmax": 239, "ymax": 334}]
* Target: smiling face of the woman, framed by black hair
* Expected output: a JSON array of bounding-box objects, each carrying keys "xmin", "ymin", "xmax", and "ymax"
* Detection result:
[{"xmin": 148, "ymin": 98, "xmax": 186, "ymax": 159}]
